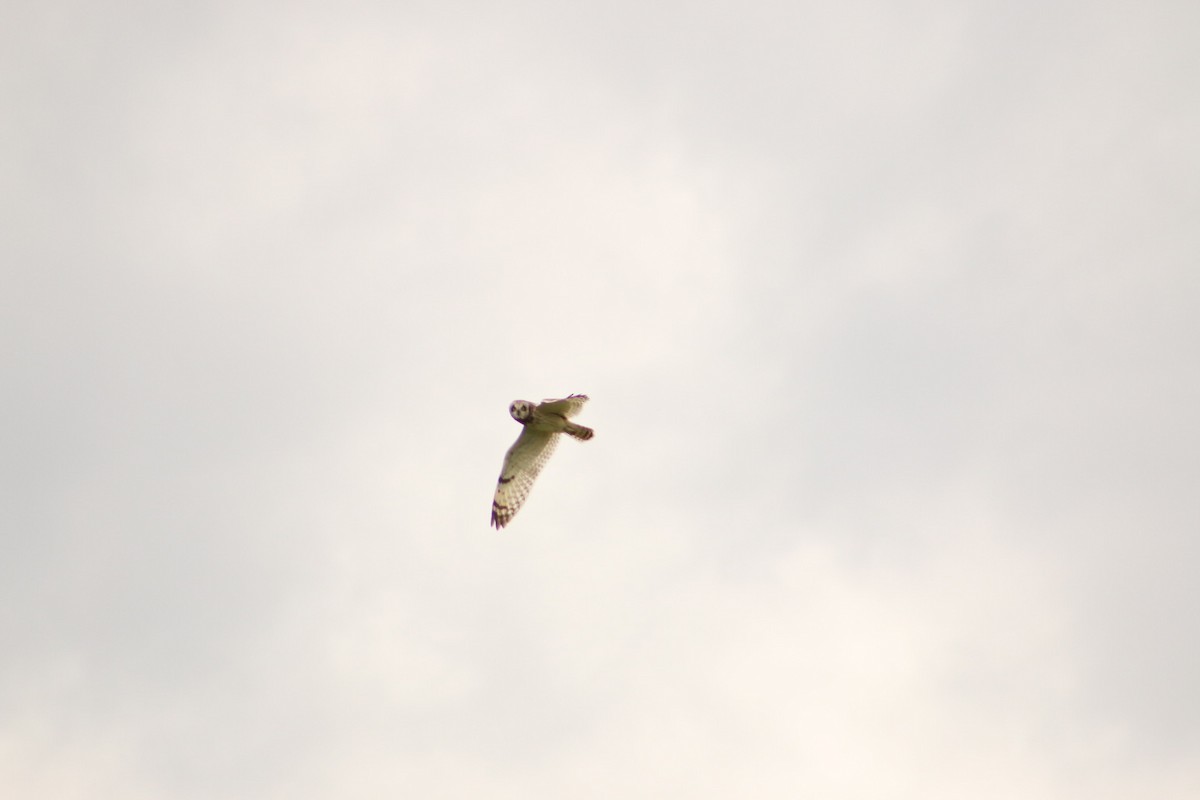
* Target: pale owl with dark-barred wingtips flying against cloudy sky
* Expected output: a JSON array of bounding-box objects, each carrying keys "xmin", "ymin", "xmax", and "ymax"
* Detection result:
[{"xmin": 492, "ymin": 395, "xmax": 594, "ymax": 530}]
